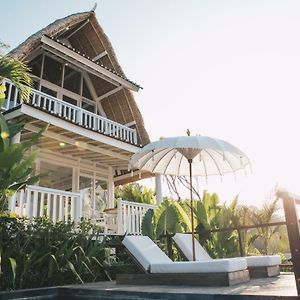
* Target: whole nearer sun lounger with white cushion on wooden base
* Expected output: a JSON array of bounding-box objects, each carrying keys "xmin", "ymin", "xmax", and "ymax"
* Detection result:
[{"xmin": 116, "ymin": 236, "xmax": 249, "ymax": 286}]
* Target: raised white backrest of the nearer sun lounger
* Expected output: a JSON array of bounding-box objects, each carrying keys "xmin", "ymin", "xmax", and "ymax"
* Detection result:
[{"xmin": 122, "ymin": 235, "xmax": 173, "ymax": 271}]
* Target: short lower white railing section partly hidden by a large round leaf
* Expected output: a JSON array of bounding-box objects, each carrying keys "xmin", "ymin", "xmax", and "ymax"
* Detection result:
[{"xmin": 117, "ymin": 199, "xmax": 157, "ymax": 234}]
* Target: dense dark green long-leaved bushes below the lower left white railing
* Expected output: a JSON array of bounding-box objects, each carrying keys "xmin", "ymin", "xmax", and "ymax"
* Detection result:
[{"xmin": 0, "ymin": 213, "xmax": 110, "ymax": 290}]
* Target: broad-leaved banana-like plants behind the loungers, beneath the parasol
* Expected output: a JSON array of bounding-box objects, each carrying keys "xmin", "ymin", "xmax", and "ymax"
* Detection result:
[{"xmin": 142, "ymin": 191, "xmax": 239, "ymax": 257}]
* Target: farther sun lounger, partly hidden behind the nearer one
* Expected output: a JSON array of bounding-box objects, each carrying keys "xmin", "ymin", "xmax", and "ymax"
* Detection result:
[{"xmin": 173, "ymin": 233, "xmax": 281, "ymax": 278}]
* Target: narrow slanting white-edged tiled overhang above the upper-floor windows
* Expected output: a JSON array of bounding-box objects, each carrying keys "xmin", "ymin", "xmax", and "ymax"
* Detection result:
[{"xmin": 41, "ymin": 36, "xmax": 140, "ymax": 92}]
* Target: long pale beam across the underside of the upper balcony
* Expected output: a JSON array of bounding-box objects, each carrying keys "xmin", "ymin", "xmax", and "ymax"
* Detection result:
[{"xmin": 24, "ymin": 124, "xmax": 129, "ymax": 161}]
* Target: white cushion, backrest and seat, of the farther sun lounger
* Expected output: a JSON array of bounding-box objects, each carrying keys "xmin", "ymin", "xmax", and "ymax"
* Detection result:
[{"xmin": 173, "ymin": 233, "xmax": 281, "ymax": 267}]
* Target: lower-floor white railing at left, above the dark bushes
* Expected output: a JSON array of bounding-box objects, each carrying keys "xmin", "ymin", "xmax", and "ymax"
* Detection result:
[{"xmin": 9, "ymin": 186, "xmax": 82, "ymax": 223}]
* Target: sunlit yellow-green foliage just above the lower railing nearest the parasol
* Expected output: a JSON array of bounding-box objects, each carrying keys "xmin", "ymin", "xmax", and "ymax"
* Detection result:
[{"xmin": 115, "ymin": 183, "xmax": 156, "ymax": 204}]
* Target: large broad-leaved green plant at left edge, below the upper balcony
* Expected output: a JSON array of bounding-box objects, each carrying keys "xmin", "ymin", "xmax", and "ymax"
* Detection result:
[{"xmin": 0, "ymin": 114, "xmax": 46, "ymax": 211}]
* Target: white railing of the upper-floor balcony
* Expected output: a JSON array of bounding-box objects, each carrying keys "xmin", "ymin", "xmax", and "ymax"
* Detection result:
[{"xmin": 2, "ymin": 79, "xmax": 137, "ymax": 144}]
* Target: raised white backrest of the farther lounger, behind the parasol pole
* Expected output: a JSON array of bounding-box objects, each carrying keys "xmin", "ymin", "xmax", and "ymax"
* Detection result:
[{"xmin": 173, "ymin": 233, "xmax": 212, "ymax": 260}]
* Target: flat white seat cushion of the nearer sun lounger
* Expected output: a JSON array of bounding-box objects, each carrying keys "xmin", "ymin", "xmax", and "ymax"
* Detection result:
[{"xmin": 150, "ymin": 258, "xmax": 247, "ymax": 273}]
